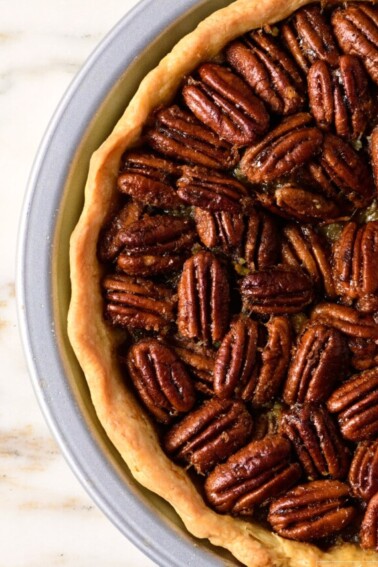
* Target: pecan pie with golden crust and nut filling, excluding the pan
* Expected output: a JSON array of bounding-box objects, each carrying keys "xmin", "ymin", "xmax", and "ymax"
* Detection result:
[{"xmin": 68, "ymin": 0, "xmax": 378, "ymax": 566}]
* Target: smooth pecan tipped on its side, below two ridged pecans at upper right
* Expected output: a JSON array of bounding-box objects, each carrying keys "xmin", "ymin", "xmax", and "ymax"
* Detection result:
[{"xmin": 256, "ymin": 183, "xmax": 341, "ymax": 222}]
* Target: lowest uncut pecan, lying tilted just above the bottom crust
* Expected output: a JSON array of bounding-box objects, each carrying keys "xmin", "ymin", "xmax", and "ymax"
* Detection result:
[{"xmin": 268, "ymin": 480, "xmax": 356, "ymax": 541}]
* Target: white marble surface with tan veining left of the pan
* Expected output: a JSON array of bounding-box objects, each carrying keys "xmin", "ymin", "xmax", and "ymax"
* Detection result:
[{"xmin": 0, "ymin": 0, "xmax": 154, "ymax": 567}]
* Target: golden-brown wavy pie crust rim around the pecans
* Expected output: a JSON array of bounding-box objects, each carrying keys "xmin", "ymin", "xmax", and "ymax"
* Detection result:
[{"xmin": 68, "ymin": 0, "xmax": 378, "ymax": 567}]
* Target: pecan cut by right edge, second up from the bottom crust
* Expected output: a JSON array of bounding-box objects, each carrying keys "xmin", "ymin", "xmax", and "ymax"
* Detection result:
[{"xmin": 349, "ymin": 441, "xmax": 378, "ymax": 500}]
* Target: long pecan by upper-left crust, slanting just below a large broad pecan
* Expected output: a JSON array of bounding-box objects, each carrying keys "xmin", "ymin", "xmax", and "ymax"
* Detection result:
[{"xmin": 145, "ymin": 105, "xmax": 239, "ymax": 169}]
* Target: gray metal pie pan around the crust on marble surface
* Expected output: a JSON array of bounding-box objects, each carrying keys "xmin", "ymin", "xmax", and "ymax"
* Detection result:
[{"xmin": 17, "ymin": 0, "xmax": 239, "ymax": 567}]
